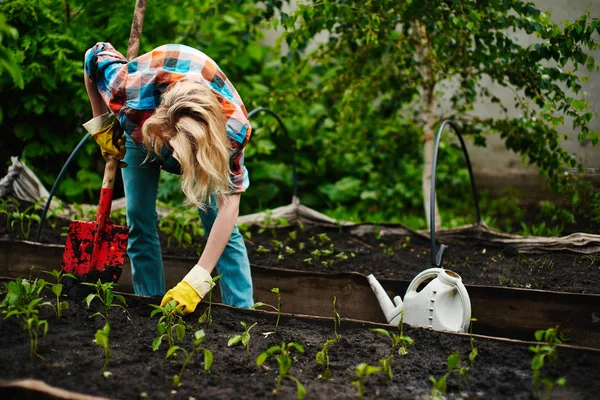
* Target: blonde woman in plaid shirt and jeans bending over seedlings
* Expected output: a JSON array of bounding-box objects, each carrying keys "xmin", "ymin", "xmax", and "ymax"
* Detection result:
[{"xmin": 84, "ymin": 43, "xmax": 253, "ymax": 313}]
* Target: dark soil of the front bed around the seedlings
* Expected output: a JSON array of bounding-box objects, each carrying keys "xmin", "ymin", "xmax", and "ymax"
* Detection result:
[{"xmin": 0, "ymin": 288, "xmax": 600, "ymax": 400}]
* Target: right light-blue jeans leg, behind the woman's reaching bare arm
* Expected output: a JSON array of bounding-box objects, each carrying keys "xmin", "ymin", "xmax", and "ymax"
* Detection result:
[{"xmin": 198, "ymin": 206, "xmax": 254, "ymax": 308}]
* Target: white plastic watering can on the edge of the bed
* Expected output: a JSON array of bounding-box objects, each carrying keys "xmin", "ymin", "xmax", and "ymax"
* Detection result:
[{"xmin": 367, "ymin": 268, "xmax": 471, "ymax": 333}]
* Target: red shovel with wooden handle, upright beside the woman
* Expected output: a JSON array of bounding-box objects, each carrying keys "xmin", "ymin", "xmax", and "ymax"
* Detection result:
[{"xmin": 62, "ymin": 0, "xmax": 146, "ymax": 283}]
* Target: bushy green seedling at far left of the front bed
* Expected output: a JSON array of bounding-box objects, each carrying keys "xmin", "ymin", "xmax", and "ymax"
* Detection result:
[{"xmin": 1, "ymin": 278, "xmax": 51, "ymax": 358}]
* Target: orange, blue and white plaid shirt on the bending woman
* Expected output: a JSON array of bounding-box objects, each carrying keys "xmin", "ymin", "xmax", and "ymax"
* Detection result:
[{"xmin": 85, "ymin": 43, "xmax": 252, "ymax": 193}]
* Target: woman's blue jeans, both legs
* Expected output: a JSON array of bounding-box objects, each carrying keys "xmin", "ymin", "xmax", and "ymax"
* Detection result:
[{"xmin": 121, "ymin": 136, "xmax": 254, "ymax": 308}]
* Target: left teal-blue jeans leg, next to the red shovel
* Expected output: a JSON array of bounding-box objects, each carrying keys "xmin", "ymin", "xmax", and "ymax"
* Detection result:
[{"xmin": 121, "ymin": 137, "xmax": 165, "ymax": 296}]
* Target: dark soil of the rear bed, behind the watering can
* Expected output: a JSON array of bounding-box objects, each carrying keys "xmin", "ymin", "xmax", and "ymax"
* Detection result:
[{"xmin": 0, "ymin": 206, "xmax": 600, "ymax": 294}]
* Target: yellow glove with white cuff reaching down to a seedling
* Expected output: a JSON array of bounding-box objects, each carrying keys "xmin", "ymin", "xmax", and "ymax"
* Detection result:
[{"xmin": 160, "ymin": 265, "xmax": 214, "ymax": 314}]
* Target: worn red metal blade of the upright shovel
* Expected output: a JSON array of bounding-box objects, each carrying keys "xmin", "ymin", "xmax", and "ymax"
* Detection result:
[{"xmin": 62, "ymin": 221, "xmax": 129, "ymax": 282}]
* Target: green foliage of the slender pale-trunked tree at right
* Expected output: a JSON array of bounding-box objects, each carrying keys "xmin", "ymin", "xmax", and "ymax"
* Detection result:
[{"xmin": 278, "ymin": 0, "xmax": 600, "ymax": 195}]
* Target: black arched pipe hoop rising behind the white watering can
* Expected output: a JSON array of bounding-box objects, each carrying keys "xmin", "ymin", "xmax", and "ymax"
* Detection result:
[{"xmin": 429, "ymin": 119, "xmax": 481, "ymax": 267}]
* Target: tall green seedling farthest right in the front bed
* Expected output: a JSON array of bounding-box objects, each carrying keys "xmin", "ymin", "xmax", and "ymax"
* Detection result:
[{"xmin": 529, "ymin": 326, "xmax": 567, "ymax": 399}]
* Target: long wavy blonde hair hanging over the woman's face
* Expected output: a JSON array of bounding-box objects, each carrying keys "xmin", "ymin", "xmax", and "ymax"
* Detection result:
[{"xmin": 142, "ymin": 80, "xmax": 231, "ymax": 210}]
